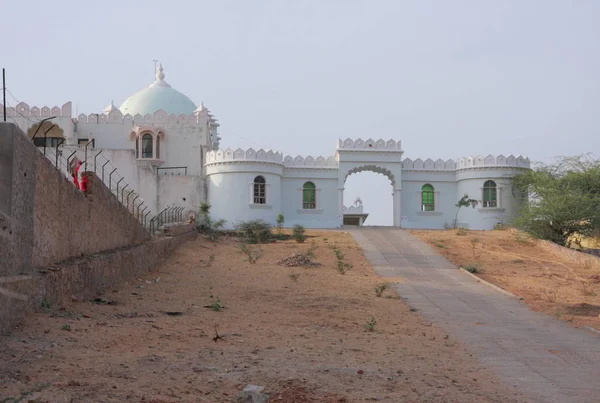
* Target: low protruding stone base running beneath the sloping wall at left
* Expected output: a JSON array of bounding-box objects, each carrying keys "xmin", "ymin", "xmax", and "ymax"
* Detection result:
[{"xmin": 0, "ymin": 231, "xmax": 197, "ymax": 334}]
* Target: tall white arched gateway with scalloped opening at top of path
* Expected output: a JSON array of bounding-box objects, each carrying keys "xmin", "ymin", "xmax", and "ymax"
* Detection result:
[{"xmin": 336, "ymin": 139, "xmax": 403, "ymax": 227}]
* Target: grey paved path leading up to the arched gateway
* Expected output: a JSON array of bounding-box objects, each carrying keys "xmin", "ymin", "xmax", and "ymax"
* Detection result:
[{"xmin": 349, "ymin": 227, "xmax": 600, "ymax": 403}]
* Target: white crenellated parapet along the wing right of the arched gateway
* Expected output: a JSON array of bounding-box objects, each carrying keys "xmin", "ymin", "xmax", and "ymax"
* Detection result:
[{"xmin": 402, "ymin": 154, "xmax": 531, "ymax": 171}]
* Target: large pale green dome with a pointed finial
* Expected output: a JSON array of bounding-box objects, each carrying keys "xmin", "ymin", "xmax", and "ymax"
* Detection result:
[{"xmin": 119, "ymin": 64, "xmax": 196, "ymax": 116}]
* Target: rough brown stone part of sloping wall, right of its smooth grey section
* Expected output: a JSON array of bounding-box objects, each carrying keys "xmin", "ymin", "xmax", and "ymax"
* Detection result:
[{"xmin": 32, "ymin": 166, "xmax": 149, "ymax": 266}]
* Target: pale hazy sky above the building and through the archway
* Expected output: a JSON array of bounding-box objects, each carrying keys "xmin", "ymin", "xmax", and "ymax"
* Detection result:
[{"xmin": 0, "ymin": 0, "xmax": 600, "ymax": 224}]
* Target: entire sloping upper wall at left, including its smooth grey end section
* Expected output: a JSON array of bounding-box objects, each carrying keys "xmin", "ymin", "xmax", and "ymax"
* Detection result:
[{"xmin": 0, "ymin": 123, "xmax": 150, "ymax": 276}]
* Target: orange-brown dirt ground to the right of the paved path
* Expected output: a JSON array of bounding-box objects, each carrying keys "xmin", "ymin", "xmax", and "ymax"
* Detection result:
[{"xmin": 411, "ymin": 230, "xmax": 600, "ymax": 330}]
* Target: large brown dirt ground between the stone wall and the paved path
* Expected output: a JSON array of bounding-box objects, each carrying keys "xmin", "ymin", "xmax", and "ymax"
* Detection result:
[{"xmin": 0, "ymin": 231, "xmax": 525, "ymax": 403}]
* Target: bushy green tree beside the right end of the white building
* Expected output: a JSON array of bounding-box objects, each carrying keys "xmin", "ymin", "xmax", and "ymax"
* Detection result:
[{"xmin": 513, "ymin": 154, "xmax": 600, "ymax": 247}]
